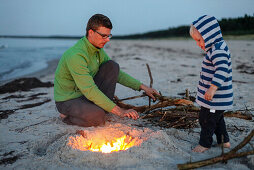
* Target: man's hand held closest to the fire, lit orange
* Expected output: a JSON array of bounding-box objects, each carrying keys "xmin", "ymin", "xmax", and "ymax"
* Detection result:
[{"xmin": 111, "ymin": 105, "xmax": 139, "ymax": 120}]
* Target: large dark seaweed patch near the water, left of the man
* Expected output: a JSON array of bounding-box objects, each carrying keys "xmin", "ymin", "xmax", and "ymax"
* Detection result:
[{"xmin": 0, "ymin": 77, "xmax": 54, "ymax": 94}]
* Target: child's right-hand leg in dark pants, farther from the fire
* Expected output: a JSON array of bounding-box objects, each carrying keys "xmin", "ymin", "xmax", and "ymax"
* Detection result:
[{"xmin": 214, "ymin": 110, "xmax": 230, "ymax": 147}]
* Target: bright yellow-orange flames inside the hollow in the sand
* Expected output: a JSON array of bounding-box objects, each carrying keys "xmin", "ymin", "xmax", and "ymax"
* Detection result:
[{"xmin": 68, "ymin": 135, "xmax": 142, "ymax": 153}]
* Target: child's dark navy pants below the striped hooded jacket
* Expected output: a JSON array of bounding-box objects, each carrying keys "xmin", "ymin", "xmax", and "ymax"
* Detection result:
[{"xmin": 199, "ymin": 107, "xmax": 229, "ymax": 148}]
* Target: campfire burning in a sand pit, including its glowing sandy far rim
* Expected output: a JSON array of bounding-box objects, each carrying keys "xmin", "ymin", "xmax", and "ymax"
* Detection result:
[{"xmin": 67, "ymin": 127, "xmax": 143, "ymax": 153}]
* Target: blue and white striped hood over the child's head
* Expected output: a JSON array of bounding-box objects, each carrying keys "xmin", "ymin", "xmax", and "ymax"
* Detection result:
[{"xmin": 192, "ymin": 15, "xmax": 223, "ymax": 51}]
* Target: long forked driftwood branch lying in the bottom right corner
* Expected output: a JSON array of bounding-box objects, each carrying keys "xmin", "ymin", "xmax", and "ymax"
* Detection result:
[{"xmin": 177, "ymin": 129, "xmax": 254, "ymax": 170}]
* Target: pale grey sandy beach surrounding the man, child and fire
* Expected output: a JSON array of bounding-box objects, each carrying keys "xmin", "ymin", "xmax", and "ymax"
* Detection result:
[{"xmin": 0, "ymin": 39, "xmax": 254, "ymax": 170}]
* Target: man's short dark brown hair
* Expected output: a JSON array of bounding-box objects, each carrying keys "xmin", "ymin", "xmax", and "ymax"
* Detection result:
[{"xmin": 86, "ymin": 14, "xmax": 113, "ymax": 36}]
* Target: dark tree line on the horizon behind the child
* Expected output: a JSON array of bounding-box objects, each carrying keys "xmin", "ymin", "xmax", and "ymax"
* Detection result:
[{"xmin": 113, "ymin": 14, "xmax": 254, "ymax": 39}]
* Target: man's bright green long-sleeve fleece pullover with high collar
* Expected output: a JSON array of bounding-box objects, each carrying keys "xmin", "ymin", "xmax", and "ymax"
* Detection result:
[{"xmin": 54, "ymin": 37, "xmax": 141, "ymax": 112}]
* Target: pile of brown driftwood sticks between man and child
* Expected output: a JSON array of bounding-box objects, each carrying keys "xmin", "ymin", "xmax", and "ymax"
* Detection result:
[{"xmin": 114, "ymin": 90, "xmax": 252, "ymax": 129}]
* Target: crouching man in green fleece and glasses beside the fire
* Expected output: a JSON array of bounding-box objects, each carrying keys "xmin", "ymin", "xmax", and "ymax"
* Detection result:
[{"xmin": 54, "ymin": 14, "xmax": 159, "ymax": 127}]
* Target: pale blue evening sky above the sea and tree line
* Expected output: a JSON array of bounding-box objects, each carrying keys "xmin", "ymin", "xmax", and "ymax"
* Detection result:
[{"xmin": 0, "ymin": 0, "xmax": 254, "ymax": 35}]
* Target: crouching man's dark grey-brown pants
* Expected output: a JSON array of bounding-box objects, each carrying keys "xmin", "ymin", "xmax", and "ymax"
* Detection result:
[{"xmin": 56, "ymin": 60, "xmax": 119, "ymax": 127}]
